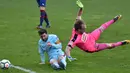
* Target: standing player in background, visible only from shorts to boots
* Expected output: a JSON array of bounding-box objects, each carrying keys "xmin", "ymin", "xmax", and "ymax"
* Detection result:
[{"xmin": 37, "ymin": 0, "xmax": 50, "ymax": 29}]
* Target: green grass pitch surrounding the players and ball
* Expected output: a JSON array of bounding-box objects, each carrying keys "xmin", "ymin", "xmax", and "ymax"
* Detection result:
[{"xmin": 0, "ymin": 0, "xmax": 130, "ymax": 73}]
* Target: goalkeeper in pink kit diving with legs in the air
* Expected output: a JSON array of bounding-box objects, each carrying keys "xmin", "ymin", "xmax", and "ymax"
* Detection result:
[{"xmin": 65, "ymin": 1, "xmax": 130, "ymax": 61}]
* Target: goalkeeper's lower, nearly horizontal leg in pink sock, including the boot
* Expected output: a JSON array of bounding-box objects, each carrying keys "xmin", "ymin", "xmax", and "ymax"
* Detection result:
[{"xmin": 96, "ymin": 40, "xmax": 130, "ymax": 51}]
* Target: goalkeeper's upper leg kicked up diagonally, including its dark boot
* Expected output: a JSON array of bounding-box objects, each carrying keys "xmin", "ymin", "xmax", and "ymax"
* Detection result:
[{"xmin": 91, "ymin": 15, "xmax": 121, "ymax": 40}]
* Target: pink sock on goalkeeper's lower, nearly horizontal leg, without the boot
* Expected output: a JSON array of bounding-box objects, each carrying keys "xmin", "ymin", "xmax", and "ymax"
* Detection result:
[{"xmin": 96, "ymin": 42, "xmax": 122, "ymax": 51}]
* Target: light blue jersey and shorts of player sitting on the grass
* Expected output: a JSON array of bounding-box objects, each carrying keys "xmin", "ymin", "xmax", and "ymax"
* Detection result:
[{"xmin": 38, "ymin": 34, "xmax": 64, "ymax": 62}]
